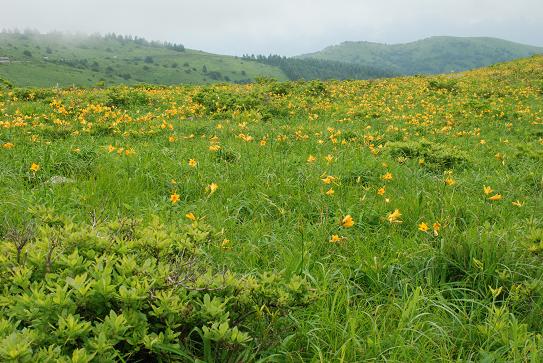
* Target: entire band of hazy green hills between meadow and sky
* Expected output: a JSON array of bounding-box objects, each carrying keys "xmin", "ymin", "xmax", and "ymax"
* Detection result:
[{"xmin": 0, "ymin": 32, "xmax": 543, "ymax": 87}]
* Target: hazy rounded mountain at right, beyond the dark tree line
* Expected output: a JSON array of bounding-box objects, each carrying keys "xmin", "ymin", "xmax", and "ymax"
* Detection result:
[{"xmin": 298, "ymin": 36, "xmax": 543, "ymax": 75}]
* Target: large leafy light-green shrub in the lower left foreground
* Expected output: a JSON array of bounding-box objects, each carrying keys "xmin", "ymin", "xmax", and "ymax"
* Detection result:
[{"xmin": 0, "ymin": 208, "xmax": 311, "ymax": 362}]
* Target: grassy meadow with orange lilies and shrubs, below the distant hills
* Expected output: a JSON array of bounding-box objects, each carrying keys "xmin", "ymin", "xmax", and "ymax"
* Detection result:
[{"xmin": 0, "ymin": 56, "xmax": 543, "ymax": 362}]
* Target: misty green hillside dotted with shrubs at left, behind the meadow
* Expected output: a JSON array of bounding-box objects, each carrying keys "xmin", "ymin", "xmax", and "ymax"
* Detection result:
[{"xmin": 0, "ymin": 32, "xmax": 287, "ymax": 87}]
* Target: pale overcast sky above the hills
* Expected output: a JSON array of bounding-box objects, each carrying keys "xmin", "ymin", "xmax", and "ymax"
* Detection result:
[{"xmin": 0, "ymin": 0, "xmax": 543, "ymax": 55}]
